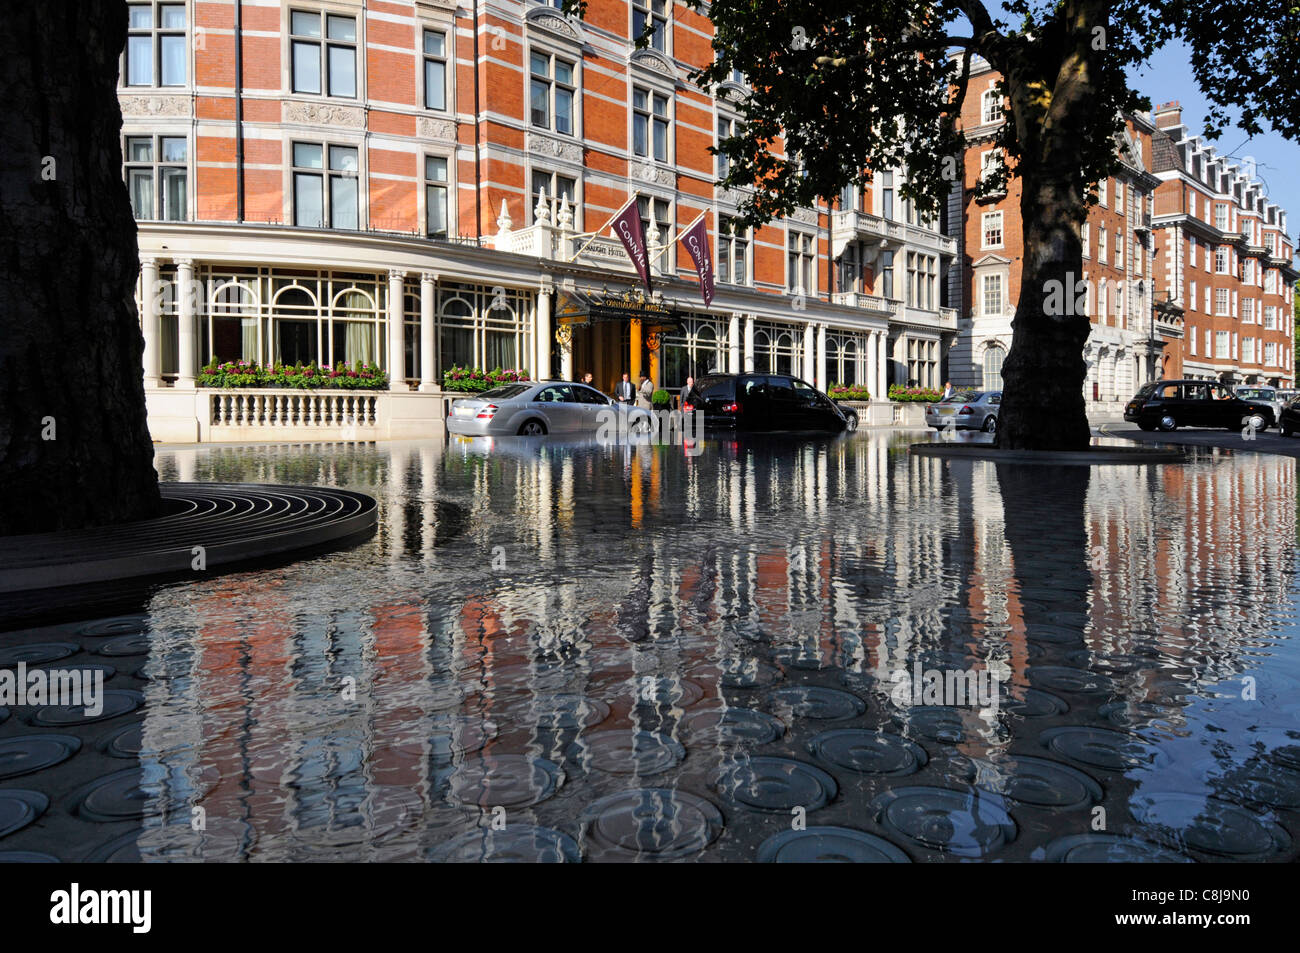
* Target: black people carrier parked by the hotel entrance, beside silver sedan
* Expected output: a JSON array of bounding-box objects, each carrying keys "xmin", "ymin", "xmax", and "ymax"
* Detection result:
[{"xmin": 681, "ymin": 374, "xmax": 858, "ymax": 433}]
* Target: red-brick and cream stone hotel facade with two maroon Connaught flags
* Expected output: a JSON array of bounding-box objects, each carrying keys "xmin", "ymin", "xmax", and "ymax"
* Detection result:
[{"xmin": 120, "ymin": 0, "xmax": 957, "ymax": 441}]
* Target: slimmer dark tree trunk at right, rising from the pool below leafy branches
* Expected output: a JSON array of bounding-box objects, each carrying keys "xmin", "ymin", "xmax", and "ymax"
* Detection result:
[{"xmin": 997, "ymin": 163, "xmax": 1091, "ymax": 450}]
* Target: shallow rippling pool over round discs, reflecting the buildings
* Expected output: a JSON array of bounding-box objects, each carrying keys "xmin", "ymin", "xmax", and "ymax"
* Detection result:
[{"xmin": 0, "ymin": 433, "xmax": 1300, "ymax": 863}]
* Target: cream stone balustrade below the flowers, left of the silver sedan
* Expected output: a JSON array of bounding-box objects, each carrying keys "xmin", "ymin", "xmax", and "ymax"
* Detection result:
[{"xmin": 208, "ymin": 390, "xmax": 381, "ymax": 429}]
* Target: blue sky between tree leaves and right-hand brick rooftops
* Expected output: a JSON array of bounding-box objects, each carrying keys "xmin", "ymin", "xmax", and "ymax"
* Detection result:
[{"xmin": 1128, "ymin": 43, "xmax": 1300, "ymax": 237}]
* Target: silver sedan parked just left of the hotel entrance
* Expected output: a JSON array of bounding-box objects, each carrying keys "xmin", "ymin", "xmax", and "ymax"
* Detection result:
[{"xmin": 447, "ymin": 381, "xmax": 653, "ymax": 437}]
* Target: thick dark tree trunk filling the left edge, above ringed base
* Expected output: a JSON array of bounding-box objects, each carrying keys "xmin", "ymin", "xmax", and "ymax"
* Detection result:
[{"xmin": 0, "ymin": 0, "xmax": 160, "ymax": 534}]
